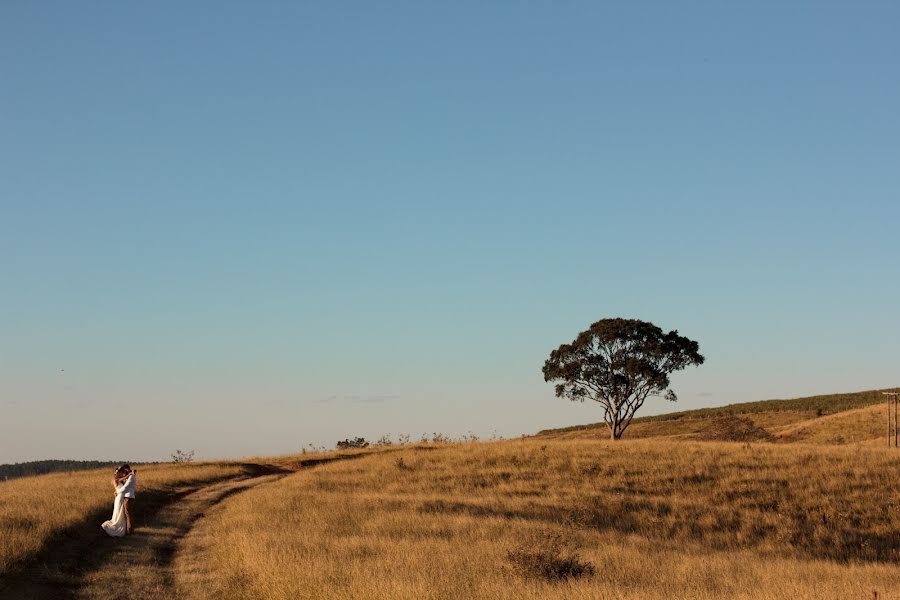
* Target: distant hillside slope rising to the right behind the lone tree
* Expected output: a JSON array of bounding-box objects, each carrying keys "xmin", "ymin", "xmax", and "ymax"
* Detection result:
[{"xmin": 538, "ymin": 388, "xmax": 900, "ymax": 444}]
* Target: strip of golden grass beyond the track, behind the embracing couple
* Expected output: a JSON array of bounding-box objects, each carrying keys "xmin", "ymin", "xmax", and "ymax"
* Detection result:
[{"xmin": 0, "ymin": 463, "xmax": 243, "ymax": 575}]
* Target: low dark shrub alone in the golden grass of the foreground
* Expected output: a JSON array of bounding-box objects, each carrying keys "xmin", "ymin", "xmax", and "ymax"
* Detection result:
[{"xmin": 506, "ymin": 532, "xmax": 594, "ymax": 581}]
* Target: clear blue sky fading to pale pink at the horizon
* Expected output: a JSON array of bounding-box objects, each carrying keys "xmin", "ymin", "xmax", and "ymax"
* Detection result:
[{"xmin": 0, "ymin": 0, "xmax": 900, "ymax": 462}]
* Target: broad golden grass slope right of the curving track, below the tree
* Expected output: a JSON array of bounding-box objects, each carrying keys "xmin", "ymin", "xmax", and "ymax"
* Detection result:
[{"xmin": 176, "ymin": 439, "xmax": 900, "ymax": 600}]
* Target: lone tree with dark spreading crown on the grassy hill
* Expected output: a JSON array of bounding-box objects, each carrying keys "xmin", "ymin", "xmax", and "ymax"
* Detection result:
[{"xmin": 544, "ymin": 319, "xmax": 704, "ymax": 440}]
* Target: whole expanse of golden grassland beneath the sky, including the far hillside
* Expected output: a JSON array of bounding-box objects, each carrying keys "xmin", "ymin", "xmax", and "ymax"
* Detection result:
[{"xmin": 0, "ymin": 392, "xmax": 900, "ymax": 600}]
